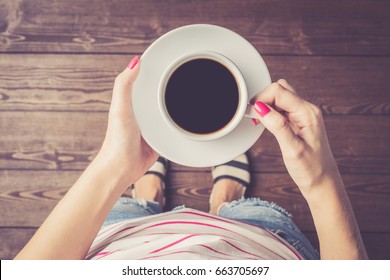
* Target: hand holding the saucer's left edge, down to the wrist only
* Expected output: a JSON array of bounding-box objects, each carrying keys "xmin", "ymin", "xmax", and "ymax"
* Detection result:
[{"xmin": 98, "ymin": 56, "xmax": 158, "ymax": 184}]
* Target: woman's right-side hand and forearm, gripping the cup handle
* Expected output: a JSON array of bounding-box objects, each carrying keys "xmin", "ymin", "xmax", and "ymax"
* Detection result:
[{"xmin": 254, "ymin": 80, "xmax": 367, "ymax": 259}]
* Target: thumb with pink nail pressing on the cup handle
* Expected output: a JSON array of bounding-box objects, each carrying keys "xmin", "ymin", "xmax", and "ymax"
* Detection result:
[{"xmin": 254, "ymin": 101, "xmax": 299, "ymax": 153}]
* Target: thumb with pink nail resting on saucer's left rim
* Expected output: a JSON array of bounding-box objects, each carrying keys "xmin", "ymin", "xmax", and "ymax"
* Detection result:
[{"xmin": 111, "ymin": 56, "xmax": 140, "ymax": 110}]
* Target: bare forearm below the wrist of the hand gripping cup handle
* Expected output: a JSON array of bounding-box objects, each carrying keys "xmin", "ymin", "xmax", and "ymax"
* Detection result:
[{"xmin": 305, "ymin": 174, "xmax": 367, "ymax": 259}]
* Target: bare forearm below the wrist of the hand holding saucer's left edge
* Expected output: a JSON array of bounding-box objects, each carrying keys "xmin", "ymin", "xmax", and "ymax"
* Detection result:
[{"xmin": 16, "ymin": 152, "xmax": 128, "ymax": 259}]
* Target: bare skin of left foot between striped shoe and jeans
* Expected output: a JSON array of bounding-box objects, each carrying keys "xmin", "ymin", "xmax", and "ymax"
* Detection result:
[{"xmin": 133, "ymin": 174, "xmax": 164, "ymax": 209}]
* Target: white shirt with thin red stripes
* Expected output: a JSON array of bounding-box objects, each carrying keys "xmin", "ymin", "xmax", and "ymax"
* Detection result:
[{"xmin": 87, "ymin": 208, "xmax": 302, "ymax": 260}]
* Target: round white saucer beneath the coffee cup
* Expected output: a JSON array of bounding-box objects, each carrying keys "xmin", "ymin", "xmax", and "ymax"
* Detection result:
[{"xmin": 133, "ymin": 24, "xmax": 271, "ymax": 167}]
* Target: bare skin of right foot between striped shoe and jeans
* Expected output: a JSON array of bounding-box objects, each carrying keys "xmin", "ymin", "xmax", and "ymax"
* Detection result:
[{"xmin": 210, "ymin": 179, "xmax": 245, "ymax": 214}]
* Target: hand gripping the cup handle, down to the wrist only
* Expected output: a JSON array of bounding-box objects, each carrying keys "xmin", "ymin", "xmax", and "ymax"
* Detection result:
[{"xmin": 253, "ymin": 80, "xmax": 341, "ymax": 197}]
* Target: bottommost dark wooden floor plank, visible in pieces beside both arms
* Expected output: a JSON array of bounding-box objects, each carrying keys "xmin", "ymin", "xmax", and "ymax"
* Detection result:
[{"xmin": 0, "ymin": 228, "xmax": 390, "ymax": 260}]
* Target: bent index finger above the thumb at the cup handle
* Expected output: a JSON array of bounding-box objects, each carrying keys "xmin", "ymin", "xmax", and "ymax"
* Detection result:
[{"xmin": 253, "ymin": 83, "xmax": 305, "ymax": 113}]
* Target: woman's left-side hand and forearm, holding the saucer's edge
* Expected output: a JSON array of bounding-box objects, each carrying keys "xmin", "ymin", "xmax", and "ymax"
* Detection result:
[{"xmin": 16, "ymin": 57, "xmax": 157, "ymax": 259}]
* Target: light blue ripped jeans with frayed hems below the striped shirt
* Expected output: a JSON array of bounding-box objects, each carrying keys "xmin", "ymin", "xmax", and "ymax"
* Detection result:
[{"xmin": 103, "ymin": 197, "xmax": 319, "ymax": 259}]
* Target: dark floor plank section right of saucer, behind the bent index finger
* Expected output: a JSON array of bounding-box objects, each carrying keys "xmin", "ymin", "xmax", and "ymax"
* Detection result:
[{"xmin": 264, "ymin": 56, "xmax": 390, "ymax": 115}]
